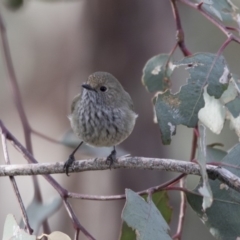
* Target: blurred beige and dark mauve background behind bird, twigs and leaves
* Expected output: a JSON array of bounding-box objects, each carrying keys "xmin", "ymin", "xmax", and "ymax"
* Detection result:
[{"xmin": 0, "ymin": 0, "xmax": 240, "ymax": 240}]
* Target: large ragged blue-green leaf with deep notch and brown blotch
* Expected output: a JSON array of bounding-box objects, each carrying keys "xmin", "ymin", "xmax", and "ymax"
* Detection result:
[{"xmin": 154, "ymin": 53, "xmax": 230, "ymax": 144}]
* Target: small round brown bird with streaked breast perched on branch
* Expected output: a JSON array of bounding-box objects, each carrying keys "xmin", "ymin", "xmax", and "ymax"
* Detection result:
[{"xmin": 64, "ymin": 72, "xmax": 137, "ymax": 175}]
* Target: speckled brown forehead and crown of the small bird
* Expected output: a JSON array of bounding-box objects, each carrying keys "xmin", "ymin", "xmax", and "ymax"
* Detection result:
[{"xmin": 87, "ymin": 72, "xmax": 117, "ymax": 87}]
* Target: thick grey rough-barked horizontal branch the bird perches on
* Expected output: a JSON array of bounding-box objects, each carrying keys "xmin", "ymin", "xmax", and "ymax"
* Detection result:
[{"xmin": 0, "ymin": 156, "xmax": 240, "ymax": 192}]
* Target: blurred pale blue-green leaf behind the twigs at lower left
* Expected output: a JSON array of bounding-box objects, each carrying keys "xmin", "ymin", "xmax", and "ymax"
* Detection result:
[{"xmin": 20, "ymin": 197, "xmax": 62, "ymax": 233}]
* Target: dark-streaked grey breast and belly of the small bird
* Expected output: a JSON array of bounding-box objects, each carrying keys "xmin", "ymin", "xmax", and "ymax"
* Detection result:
[{"xmin": 70, "ymin": 101, "xmax": 136, "ymax": 147}]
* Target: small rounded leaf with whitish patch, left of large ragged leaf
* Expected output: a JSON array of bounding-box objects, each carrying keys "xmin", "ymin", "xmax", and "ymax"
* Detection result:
[{"xmin": 142, "ymin": 54, "xmax": 174, "ymax": 92}]
